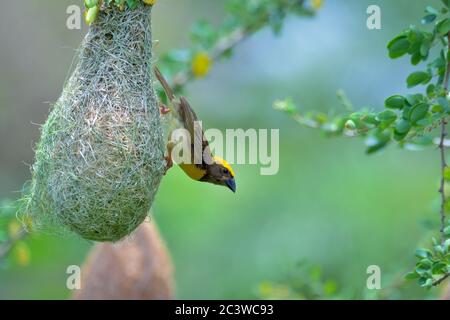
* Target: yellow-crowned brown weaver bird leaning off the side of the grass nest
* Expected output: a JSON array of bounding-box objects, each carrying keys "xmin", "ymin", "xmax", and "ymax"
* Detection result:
[{"xmin": 154, "ymin": 67, "xmax": 236, "ymax": 192}]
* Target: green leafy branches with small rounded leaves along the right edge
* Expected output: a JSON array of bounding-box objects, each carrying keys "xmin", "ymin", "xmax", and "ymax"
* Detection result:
[{"xmin": 274, "ymin": 0, "xmax": 450, "ymax": 287}]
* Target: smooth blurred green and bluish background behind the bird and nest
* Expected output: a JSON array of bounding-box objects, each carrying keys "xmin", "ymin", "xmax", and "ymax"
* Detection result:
[{"xmin": 0, "ymin": 0, "xmax": 439, "ymax": 299}]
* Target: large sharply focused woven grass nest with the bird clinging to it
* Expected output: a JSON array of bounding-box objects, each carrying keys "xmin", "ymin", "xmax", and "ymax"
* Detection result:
[{"xmin": 24, "ymin": 4, "xmax": 165, "ymax": 241}]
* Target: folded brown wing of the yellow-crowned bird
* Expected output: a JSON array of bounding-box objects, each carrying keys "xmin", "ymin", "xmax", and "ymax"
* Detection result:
[{"xmin": 179, "ymin": 97, "xmax": 213, "ymax": 164}]
